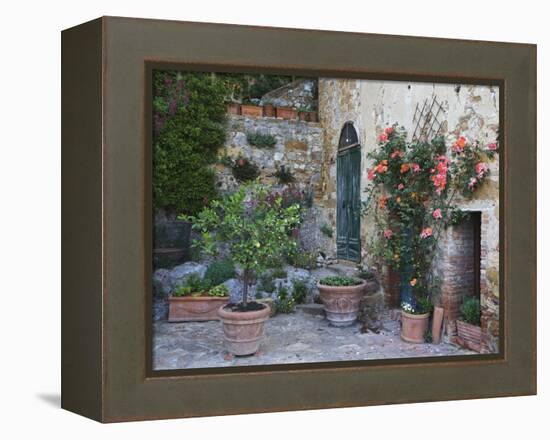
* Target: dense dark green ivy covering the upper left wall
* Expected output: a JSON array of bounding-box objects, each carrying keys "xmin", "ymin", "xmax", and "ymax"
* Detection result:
[{"xmin": 153, "ymin": 71, "xmax": 227, "ymax": 215}]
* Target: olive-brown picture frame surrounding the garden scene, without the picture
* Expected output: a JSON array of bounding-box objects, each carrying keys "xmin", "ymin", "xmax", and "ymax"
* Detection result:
[{"xmin": 62, "ymin": 17, "xmax": 536, "ymax": 422}]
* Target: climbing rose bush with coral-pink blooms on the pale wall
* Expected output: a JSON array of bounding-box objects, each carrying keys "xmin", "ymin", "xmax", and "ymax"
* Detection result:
[{"xmin": 364, "ymin": 125, "xmax": 498, "ymax": 309}]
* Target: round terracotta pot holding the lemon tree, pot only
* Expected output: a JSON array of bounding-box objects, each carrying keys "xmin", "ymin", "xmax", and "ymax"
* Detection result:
[{"xmin": 218, "ymin": 304, "xmax": 271, "ymax": 356}]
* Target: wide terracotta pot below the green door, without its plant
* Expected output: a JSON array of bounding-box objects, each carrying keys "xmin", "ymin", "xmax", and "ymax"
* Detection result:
[{"xmin": 317, "ymin": 281, "xmax": 366, "ymax": 327}]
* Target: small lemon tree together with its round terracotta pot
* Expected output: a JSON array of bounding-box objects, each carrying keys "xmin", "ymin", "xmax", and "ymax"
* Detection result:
[{"xmin": 185, "ymin": 182, "xmax": 300, "ymax": 356}]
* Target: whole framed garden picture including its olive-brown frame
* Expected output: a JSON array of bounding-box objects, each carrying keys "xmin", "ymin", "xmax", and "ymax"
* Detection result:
[{"xmin": 62, "ymin": 17, "xmax": 536, "ymax": 422}]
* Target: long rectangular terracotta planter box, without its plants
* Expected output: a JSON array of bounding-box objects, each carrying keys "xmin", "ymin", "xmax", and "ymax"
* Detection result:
[{"xmin": 168, "ymin": 296, "xmax": 229, "ymax": 322}]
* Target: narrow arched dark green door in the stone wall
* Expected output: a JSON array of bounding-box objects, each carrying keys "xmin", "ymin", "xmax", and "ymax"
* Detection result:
[{"xmin": 336, "ymin": 122, "xmax": 361, "ymax": 261}]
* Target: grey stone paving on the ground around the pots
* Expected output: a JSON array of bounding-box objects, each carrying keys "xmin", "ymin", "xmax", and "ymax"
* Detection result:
[{"xmin": 153, "ymin": 311, "xmax": 477, "ymax": 370}]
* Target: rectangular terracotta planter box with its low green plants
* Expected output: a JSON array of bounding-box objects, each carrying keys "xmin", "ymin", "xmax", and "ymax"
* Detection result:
[{"xmin": 168, "ymin": 274, "xmax": 229, "ymax": 322}]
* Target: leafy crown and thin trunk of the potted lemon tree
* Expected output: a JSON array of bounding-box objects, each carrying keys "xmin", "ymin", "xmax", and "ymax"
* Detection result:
[{"xmin": 191, "ymin": 183, "xmax": 300, "ymax": 303}]
